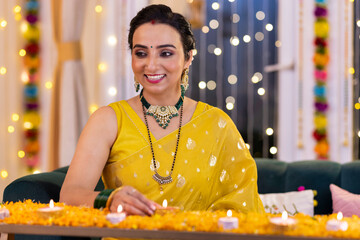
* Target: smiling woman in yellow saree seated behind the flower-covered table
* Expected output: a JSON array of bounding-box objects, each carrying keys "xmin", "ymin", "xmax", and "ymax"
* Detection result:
[{"xmin": 60, "ymin": 5, "xmax": 264, "ymax": 222}]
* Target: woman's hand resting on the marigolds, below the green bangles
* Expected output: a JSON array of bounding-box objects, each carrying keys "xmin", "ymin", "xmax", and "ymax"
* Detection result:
[{"xmin": 110, "ymin": 186, "xmax": 160, "ymax": 216}]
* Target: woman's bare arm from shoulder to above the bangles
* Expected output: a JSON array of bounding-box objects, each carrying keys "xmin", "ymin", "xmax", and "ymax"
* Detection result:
[{"xmin": 60, "ymin": 106, "xmax": 117, "ymax": 206}]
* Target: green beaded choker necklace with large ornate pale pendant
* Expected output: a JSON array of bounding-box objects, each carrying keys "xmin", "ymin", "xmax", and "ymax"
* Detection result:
[{"xmin": 140, "ymin": 86, "xmax": 185, "ymax": 129}]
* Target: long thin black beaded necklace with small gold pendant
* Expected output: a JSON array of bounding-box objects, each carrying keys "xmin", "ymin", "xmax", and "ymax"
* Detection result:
[{"xmin": 142, "ymin": 103, "xmax": 184, "ymax": 185}]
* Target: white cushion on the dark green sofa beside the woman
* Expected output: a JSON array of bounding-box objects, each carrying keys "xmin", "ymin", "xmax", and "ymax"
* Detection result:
[{"xmin": 259, "ymin": 190, "xmax": 314, "ymax": 216}]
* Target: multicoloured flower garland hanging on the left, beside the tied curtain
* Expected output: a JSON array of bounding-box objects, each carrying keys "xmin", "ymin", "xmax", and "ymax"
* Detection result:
[{"xmin": 24, "ymin": 0, "xmax": 41, "ymax": 171}]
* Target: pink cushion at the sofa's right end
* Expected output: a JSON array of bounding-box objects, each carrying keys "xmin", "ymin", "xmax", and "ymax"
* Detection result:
[{"xmin": 330, "ymin": 184, "xmax": 360, "ymax": 217}]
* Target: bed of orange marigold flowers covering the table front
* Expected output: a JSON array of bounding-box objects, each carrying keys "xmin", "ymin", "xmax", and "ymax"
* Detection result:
[{"xmin": 0, "ymin": 200, "xmax": 360, "ymax": 239}]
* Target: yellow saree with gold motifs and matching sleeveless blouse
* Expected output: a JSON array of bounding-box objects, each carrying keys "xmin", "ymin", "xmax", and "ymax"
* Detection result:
[{"xmin": 102, "ymin": 101, "xmax": 264, "ymax": 212}]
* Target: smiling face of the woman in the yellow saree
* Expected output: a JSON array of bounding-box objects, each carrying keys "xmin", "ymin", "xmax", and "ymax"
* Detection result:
[{"xmin": 131, "ymin": 23, "xmax": 192, "ymax": 96}]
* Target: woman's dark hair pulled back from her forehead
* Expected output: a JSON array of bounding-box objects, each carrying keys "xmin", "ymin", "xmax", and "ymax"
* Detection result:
[{"xmin": 128, "ymin": 4, "xmax": 195, "ymax": 60}]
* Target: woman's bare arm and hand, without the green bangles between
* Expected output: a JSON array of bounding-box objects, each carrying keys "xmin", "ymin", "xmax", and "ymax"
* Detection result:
[{"xmin": 60, "ymin": 107, "xmax": 158, "ymax": 215}]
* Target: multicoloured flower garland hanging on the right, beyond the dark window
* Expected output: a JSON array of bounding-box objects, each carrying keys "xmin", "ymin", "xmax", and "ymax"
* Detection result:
[{"xmin": 313, "ymin": 0, "xmax": 329, "ymax": 160}]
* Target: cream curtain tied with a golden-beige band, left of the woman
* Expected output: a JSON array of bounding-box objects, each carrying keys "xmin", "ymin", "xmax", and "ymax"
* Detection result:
[{"xmin": 49, "ymin": 0, "xmax": 88, "ymax": 168}]
